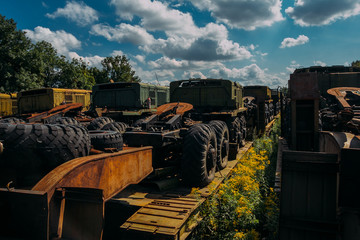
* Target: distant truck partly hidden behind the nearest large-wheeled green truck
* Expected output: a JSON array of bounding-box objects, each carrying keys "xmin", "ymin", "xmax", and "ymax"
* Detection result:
[{"xmin": 244, "ymin": 85, "xmax": 274, "ymax": 132}]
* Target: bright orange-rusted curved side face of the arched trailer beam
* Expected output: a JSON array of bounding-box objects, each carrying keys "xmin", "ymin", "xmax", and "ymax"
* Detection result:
[{"xmin": 32, "ymin": 147, "xmax": 152, "ymax": 201}]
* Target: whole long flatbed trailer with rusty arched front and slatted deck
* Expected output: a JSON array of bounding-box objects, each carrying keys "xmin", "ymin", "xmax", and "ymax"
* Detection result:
[{"xmin": 0, "ymin": 116, "xmax": 273, "ymax": 240}]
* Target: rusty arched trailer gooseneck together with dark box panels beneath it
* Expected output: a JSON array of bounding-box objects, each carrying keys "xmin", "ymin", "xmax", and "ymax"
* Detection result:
[{"xmin": 0, "ymin": 147, "xmax": 153, "ymax": 240}]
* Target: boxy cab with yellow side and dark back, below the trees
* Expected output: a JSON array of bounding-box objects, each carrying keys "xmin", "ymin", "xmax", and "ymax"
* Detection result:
[{"xmin": 17, "ymin": 88, "xmax": 91, "ymax": 113}]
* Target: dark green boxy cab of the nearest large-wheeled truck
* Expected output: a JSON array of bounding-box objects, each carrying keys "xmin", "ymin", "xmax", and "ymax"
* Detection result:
[{"xmin": 170, "ymin": 79, "xmax": 243, "ymax": 111}]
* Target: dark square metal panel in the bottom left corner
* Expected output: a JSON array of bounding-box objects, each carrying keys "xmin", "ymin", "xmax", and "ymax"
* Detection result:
[{"xmin": 0, "ymin": 188, "xmax": 48, "ymax": 240}]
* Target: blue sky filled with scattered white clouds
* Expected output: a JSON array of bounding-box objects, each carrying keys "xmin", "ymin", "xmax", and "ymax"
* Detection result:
[{"xmin": 0, "ymin": 0, "xmax": 360, "ymax": 88}]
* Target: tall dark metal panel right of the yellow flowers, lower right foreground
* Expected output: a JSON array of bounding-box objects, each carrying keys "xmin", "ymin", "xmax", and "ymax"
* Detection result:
[{"xmin": 279, "ymin": 151, "xmax": 339, "ymax": 240}]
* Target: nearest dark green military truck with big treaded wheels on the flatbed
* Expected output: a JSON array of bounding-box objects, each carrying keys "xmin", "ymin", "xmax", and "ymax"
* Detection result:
[{"xmin": 124, "ymin": 79, "xmax": 246, "ymax": 186}]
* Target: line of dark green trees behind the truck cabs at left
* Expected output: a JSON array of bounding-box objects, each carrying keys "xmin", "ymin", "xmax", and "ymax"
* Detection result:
[{"xmin": 0, "ymin": 14, "xmax": 141, "ymax": 93}]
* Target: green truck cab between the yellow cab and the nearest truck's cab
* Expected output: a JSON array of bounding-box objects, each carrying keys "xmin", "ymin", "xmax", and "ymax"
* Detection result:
[{"xmin": 92, "ymin": 82, "xmax": 169, "ymax": 124}]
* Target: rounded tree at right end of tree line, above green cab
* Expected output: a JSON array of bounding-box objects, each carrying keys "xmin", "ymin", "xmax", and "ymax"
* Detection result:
[{"xmin": 101, "ymin": 55, "xmax": 141, "ymax": 83}]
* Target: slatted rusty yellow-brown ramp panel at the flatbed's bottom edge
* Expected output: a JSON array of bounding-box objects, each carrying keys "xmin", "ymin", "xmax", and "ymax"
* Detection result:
[{"xmin": 121, "ymin": 197, "xmax": 203, "ymax": 239}]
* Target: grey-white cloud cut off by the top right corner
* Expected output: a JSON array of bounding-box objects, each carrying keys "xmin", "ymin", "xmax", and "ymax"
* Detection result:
[{"xmin": 285, "ymin": 0, "xmax": 360, "ymax": 26}]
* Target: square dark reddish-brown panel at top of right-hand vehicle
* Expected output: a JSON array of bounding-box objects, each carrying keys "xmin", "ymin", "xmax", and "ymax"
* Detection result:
[{"xmin": 289, "ymin": 72, "xmax": 320, "ymax": 100}]
